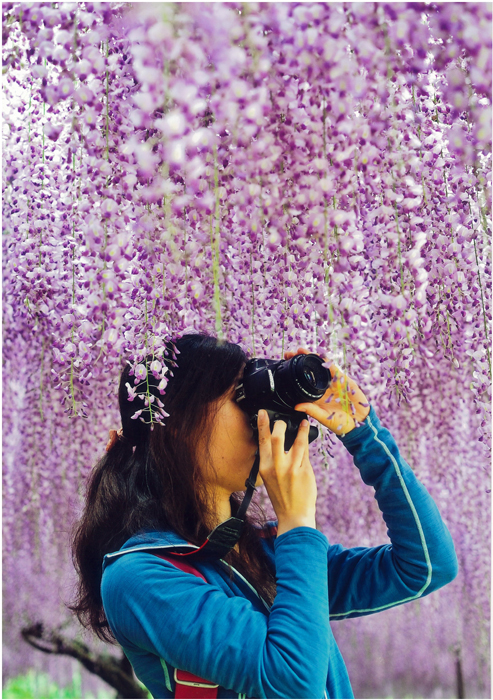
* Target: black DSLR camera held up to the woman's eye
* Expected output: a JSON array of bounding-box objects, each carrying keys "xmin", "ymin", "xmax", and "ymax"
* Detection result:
[{"xmin": 236, "ymin": 354, "xmax": 332, "ymax": 450}]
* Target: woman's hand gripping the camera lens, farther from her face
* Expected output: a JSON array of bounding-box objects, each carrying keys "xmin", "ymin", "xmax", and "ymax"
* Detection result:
[{"xmin": 284, "ymin": 348, "xmax": 370, "ymax": 435}]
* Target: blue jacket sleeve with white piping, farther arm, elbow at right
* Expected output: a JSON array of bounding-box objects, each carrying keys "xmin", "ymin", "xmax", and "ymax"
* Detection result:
[{"xmin": 322, "ymin": 407, "xmax": 458, "ymax": 620}]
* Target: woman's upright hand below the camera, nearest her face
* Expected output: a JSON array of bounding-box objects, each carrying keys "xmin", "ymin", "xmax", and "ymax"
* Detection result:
[{"xmin": 257, "ymin": 410, "xmax": 317, "ymax": 536}]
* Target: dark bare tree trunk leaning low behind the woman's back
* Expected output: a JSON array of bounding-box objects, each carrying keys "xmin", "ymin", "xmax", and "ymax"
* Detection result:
[{"xmin": 21, "ymin": 622, "xmax": 148, "ymax": 698}]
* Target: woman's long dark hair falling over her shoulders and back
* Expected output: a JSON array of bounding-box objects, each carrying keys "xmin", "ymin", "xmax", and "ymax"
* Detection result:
[{"xmin": 68, "ymin": 334, "xmax": 276, "ymax": 643}]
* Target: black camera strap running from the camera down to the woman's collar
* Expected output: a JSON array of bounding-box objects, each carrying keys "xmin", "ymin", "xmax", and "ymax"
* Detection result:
[{"xmin": 165, "ymin": 450, "xmax": 260, "ymax": 559}]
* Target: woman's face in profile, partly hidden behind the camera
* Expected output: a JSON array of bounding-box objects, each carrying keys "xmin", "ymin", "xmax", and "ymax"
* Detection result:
[{"xmin": 200, "ymin": 382, "xmax": 263, "ymax": 496}]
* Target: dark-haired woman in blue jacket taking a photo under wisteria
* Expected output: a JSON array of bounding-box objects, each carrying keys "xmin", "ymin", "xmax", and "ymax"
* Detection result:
[{"xmin": 73, "ymin": 335, "xmax": 457, "ymax": 698}]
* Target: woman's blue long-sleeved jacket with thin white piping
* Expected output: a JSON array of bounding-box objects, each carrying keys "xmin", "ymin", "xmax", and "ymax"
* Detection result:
[{"xmin": 101, "ymin": 407, "xmax": 457, "ymax": 698}]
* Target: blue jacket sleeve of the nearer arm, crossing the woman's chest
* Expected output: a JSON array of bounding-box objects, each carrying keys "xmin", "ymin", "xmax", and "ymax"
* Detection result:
[{"xmin": 101, "ymin": 527, "xmax": 330, "ymax": 698}]
